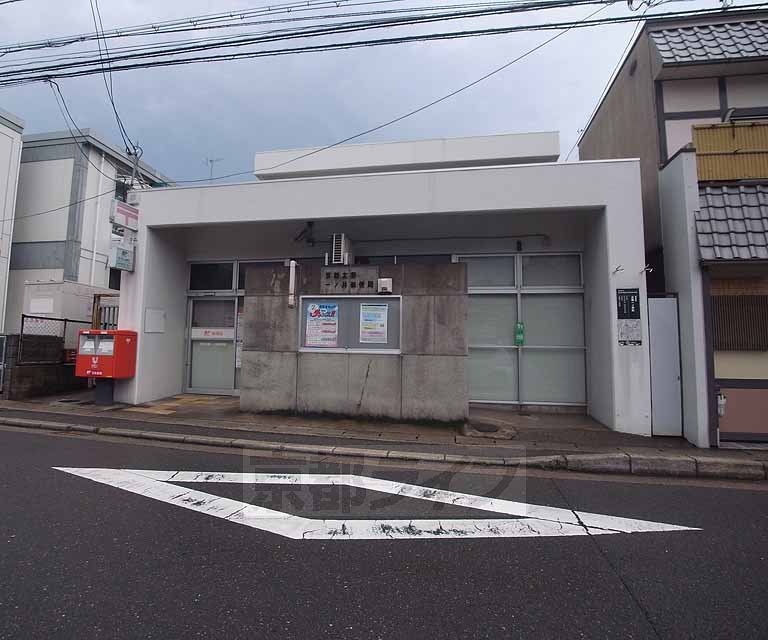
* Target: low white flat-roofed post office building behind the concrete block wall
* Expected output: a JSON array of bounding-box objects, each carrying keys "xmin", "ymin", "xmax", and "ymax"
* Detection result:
[{"xmin": 116, "ymin": 133, "xmax": 652, "ymax": 435}]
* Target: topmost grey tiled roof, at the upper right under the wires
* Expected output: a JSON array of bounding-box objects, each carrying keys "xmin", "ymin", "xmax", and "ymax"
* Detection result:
[{"xmin": 650, "ymin": 20, "xmax": 768, "ymax": 64}]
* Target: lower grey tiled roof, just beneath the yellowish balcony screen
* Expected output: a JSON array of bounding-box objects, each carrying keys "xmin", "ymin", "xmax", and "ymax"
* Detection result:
[{"xmin": 696, "ymin": 184, "xmax": 768, "ymax": 260}]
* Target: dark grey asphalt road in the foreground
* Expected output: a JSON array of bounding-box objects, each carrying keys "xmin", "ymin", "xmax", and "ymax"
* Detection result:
[{"xmin": 0, "ymin": 429, "xmax": 768, "ymax": 639}]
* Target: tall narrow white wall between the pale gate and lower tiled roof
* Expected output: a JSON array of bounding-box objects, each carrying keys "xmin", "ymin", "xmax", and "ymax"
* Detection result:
[{"xmin": 659, "ymin": 152, "xmax": 710, "ymax": 447}]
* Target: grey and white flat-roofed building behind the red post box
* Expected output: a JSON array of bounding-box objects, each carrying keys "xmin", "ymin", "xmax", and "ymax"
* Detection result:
[{"xmin": 4, "ymin": 129, "xmax": 169, "ymax": 333}]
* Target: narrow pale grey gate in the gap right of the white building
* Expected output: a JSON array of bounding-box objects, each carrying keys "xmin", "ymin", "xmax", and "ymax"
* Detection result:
[{"xmin": 648, "ymin": 296, "xmax": 683, "ymax": 437}]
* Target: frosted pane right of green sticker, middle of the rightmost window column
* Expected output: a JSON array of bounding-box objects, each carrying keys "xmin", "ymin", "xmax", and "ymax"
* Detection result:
[{"xmin": 521, "ymin": 293, "xmax": 584, "ymax": 347}]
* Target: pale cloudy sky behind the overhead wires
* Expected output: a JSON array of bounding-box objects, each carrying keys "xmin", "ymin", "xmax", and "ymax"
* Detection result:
[{"xmin": 0, "ymin": 0, "xmax": 752, "ymax": 179}]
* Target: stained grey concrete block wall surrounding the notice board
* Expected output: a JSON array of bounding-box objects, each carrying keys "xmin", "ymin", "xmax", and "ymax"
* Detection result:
[{"xmin": 240, "ymin": 264, "xmax": 469, "ymax": 422}]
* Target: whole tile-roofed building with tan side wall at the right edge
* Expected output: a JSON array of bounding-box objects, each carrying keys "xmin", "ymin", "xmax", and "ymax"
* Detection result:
[{"xmin": 579, "ymin": 11, "xmax": 768, "ymax": 446}]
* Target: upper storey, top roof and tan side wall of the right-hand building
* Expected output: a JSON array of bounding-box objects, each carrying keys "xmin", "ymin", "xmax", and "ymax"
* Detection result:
[{"xmin": 579, "ymin": 10, "xmax": 768, "ymax": 292}]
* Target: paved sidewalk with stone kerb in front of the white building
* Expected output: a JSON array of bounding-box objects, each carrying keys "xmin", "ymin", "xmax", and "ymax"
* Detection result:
[{"xmin": 0, "ymin": 393, "xmax": 768, "ymax": 480}]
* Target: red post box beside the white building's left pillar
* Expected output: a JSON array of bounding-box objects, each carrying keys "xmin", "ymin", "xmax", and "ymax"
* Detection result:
[{"xmin": 75, "ymin": 329, "xmax": 138, "ymax": 379}]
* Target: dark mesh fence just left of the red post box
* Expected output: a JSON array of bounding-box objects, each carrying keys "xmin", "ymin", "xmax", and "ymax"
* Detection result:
[{"xmin": 17, "ymin": 314, "xmax": 91, "ymax": 364}]
